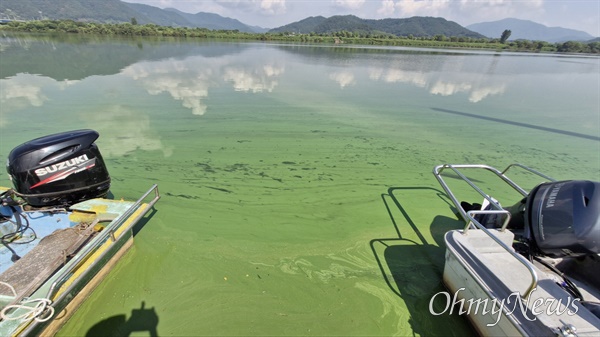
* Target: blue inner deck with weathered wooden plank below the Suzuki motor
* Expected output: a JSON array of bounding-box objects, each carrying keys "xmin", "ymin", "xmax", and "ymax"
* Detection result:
[{"xmin": 0, "ymin": 199, "xmax": 133, "ymax": 306}]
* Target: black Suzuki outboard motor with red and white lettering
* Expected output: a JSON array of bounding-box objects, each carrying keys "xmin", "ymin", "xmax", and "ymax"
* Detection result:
[{"xmin": 6, "ymin": 130, "xmax": 110, "ymax": 207}]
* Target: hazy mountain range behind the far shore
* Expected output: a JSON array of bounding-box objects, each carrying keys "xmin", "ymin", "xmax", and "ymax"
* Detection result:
[{"xmin": 0, "ymin": 0, "xmax": 593, "ymax": 42}]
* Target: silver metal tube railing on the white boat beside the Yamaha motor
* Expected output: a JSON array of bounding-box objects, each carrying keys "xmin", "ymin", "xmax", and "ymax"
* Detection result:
[{"xmin": 433, "ymin": 163, "xmax": 556, "ymax": 298}]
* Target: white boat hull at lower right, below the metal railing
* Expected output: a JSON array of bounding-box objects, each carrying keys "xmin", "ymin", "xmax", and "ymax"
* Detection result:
[{"xmin": 443, "ymin": 229, "xmax": 600, "ymax": 336}]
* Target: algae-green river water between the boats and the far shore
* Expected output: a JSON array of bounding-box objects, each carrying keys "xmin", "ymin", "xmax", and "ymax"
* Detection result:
[{"xmin": 0, "ymin": 35, "xmax": 600, "ymax": 336}]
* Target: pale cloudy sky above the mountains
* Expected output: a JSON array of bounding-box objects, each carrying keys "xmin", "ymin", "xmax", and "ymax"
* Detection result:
[{"xmin": 125, "ymin": 0, "xmax": 600, "ymax": 36}]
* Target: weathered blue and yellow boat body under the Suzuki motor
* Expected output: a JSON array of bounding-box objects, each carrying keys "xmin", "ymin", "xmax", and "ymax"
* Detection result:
[{"xmin": 0, "ymin": 185, "xmax": 160, "ymax": 335}]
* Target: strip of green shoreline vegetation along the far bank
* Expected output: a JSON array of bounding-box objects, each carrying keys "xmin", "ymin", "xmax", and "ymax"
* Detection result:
[{"xmin": 0, "ymin": 19, "xmax": 600, "ymax": 54}]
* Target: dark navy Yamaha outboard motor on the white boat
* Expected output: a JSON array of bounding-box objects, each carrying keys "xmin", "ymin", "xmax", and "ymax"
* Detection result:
[{"xmin": 524, "ymin": 180, "xmax": 600, "ymax": 257}]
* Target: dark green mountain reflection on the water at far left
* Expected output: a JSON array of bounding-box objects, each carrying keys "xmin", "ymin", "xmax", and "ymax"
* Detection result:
[{"xmin": 0, "ymin": 34, "xmax": 250, "ymax": 81}]
